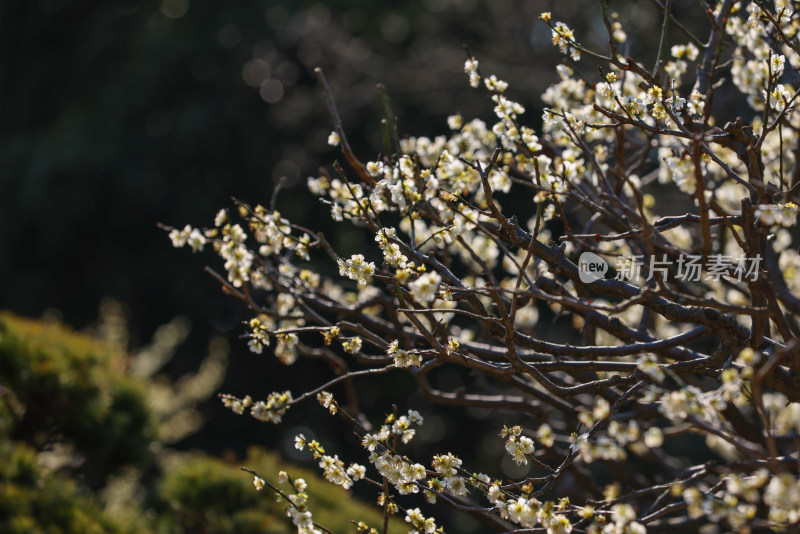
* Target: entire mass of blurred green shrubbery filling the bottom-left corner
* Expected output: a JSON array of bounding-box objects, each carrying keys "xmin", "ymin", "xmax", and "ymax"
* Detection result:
[{"xmin": 0, "ymin": 312, "xmax": 402, "ymax": 534}]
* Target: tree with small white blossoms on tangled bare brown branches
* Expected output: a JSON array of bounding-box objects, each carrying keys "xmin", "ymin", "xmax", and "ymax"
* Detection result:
[{"xmin": 168, "ymin": 0, "xmax": 800, "ymax": 533}]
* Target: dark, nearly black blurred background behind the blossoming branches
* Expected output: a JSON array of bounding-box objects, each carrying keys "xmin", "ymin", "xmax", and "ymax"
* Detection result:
[{"xmin": 0, "ymin": 0, "xmax": 705, "ymax": 516}]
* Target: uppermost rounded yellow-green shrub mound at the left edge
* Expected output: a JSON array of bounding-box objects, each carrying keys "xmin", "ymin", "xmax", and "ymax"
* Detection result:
[{"xmin": 0, "ymin": 313, "xmax": 156, "ymax": 481}]
